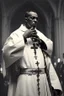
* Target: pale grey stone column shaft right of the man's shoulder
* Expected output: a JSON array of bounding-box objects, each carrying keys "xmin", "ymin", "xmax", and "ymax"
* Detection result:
[{"xmin": 54, "ymin": 17, "xmax": 62, "ymax": 59}]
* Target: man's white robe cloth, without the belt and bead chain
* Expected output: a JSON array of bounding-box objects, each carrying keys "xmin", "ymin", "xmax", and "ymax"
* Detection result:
[{"xmin": 2, "ymin": 25, "xmax": 62, "ymax": 96}]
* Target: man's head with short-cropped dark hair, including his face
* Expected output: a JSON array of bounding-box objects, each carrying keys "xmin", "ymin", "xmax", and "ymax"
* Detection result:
[{"xmin": 25, "ymin": 11, "xmax": 38, "ymax": 29}]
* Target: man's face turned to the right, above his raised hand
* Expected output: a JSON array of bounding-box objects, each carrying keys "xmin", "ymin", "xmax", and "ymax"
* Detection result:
[{"xmin": 27, "ymin": 12, "xmax": 38, "ymax": 28}]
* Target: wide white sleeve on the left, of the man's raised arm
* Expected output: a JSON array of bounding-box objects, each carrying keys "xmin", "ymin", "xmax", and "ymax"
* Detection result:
[{"xmin": 2, "ymin": 30, "xmax": 25, "ymax": 68}]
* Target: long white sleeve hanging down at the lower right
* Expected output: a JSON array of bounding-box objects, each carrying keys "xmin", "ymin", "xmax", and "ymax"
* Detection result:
[{"xmin": 47, "ymin": 58, "xmax": 62, "ymax": 91}]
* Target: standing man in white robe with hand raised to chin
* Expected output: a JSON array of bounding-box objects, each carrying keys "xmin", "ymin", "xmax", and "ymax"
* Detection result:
[{"xmin": 2, "ymin": 11, "xmax": 62, "ymax": 96}]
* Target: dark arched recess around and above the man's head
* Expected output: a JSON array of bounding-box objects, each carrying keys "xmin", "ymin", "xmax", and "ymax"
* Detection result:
[{"xmin": 11, "ymin": 1, "xmax": 47, "ymax": 32}]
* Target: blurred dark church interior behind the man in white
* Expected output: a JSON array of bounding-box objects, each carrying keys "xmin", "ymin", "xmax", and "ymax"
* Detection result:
[{"xmin": 0, "ymin": 0, "xmax": 64, "ymax": 96}]
